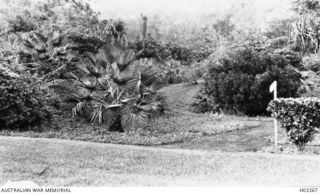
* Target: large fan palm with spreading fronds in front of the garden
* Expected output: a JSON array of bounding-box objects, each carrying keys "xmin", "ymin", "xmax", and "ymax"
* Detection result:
[{"xmin": 51, "ymin": 42, "xmax": 164, "ymax": 131}]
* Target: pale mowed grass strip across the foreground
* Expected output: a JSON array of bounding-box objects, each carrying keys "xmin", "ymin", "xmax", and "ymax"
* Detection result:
[{"xmin": 0, "ymin": 137, "xmax": 320, "ymax": 186}]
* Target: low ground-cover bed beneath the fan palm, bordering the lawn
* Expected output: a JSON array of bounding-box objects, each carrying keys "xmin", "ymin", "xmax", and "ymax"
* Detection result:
[{"xmin": 0, "ymin": 114, "xmax": 260, "ymax": 146}]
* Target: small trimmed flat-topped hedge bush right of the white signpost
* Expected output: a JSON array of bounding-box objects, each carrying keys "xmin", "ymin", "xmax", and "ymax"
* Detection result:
[{"xmin": 268, "ymin": 98, "xmax": 320, "ymax": 150}]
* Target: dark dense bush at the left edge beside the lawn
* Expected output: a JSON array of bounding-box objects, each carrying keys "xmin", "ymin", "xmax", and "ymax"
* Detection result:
[{"xmin": 0, "ymin": 69, "xmax": 50, "ymax": 130}]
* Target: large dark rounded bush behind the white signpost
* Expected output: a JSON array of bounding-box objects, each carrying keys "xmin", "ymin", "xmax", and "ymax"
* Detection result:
[{"xmin": 198, "ymin": 46, "xmax": 301, "ymax": 115}]
